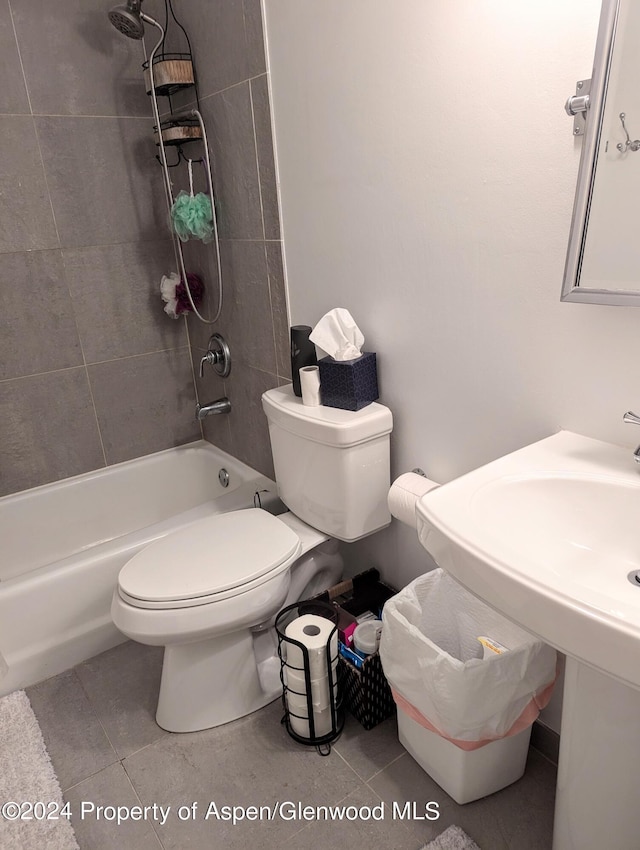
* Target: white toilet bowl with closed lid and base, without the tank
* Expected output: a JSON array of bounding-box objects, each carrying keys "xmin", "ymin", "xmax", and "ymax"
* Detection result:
[{"xmin": 111, "ymin": 508, "xmax": 342, "ymax": 732}]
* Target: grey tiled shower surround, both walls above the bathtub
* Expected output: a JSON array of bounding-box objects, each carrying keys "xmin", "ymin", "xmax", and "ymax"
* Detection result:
[{"xmin": 0, "ymin": 0, "xmax": 288, "ymax": 494}]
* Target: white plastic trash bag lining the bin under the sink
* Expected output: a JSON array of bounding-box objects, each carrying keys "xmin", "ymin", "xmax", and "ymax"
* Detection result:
[{"xmin": 380, "ymin": 569, "xmax": 556, "ymax": 749}]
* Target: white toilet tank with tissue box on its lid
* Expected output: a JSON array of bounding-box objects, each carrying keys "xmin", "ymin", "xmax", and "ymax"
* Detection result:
[{"xmin": 262, "ymin": 384, "xmax": 393, "ymax": 542}]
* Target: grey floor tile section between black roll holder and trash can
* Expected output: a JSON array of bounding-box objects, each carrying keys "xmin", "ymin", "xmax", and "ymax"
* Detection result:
[{"xmin": 334, "ymin": 715, "xmax": 405, "ymax": 781}]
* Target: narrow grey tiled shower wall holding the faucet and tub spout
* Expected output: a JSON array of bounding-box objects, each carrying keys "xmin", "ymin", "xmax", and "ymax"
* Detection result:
[{"xmin": 166, "ymin": 0, "xmax": 290, "ymax": 475}]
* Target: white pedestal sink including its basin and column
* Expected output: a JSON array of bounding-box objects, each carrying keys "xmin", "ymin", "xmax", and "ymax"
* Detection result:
[{"xmin": 416, "ymin": 431, "xmax": 640, "ymax": 850}]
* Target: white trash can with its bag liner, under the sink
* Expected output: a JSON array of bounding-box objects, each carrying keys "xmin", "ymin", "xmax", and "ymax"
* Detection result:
[{"xmin": 380, "ymin": 569, "xmax": 556, "ymax": 803}]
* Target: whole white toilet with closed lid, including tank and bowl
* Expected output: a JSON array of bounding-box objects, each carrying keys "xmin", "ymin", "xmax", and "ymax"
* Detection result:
[{"xmin": 111, "ymin": 385, "xmax": 393, "ymax": 732}]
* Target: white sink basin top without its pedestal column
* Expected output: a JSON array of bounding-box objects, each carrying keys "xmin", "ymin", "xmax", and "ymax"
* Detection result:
[{"xmin": 416, "ymin": 431, "xmax": 640, "ymax": 688}]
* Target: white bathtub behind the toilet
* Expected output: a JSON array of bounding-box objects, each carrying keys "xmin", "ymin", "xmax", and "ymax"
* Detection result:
[{"xmin": 0, "ymin": 441, "xmax": 276, "ymax": 696}]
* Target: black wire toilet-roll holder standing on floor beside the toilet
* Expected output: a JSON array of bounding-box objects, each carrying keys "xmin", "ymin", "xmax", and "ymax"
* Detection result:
[{"xmin": 275, "ymin": 600, "xmax": 344, "ymax": 756}]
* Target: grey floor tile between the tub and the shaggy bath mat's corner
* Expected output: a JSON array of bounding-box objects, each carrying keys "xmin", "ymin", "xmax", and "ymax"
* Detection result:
[{"xmin": 27, "ymin": 670, "xmax": 118, "ymax": 790}]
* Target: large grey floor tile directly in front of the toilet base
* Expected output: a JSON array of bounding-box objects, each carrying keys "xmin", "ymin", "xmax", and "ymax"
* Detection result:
[{"xmin": 124, "ymin": 701, "xmax": 362, "ymax": 850}]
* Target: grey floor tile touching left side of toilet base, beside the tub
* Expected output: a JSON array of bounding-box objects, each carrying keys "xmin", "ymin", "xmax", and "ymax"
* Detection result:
[{"xmin": 76, "ymin": 641, "xmax": 169, "ymax": 758}]
